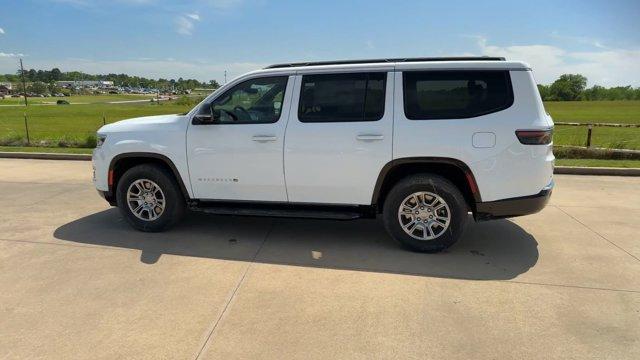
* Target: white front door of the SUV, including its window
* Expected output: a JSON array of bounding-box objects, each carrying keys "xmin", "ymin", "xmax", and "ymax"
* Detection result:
[{"xmin": 187, "ymin": 76, "xmax": 293, "ymax": 201}]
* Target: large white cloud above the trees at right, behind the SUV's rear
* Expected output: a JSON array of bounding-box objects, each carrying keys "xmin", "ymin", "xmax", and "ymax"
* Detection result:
[{"xmin": 473, "ymin": 36, "xmax": 640, "ymax": 87}]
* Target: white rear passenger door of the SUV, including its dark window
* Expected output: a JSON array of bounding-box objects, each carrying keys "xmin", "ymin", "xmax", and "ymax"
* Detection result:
[{"xmin": 284, "ymin": 67, "xmax": 394, "ymax": 204}]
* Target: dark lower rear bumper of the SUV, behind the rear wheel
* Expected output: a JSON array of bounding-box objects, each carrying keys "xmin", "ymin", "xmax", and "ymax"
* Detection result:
[{"xmin": 475, "ymin": 181, "xmax": 554, "ymax": 221}]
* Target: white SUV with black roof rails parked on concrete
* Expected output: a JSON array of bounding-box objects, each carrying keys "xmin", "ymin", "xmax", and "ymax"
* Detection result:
[{"xmin": 93, "ymin": 57, "xmax": 554, "ymax": 252}]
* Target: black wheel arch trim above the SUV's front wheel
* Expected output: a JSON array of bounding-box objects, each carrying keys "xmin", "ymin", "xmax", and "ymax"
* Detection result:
[{"xmin": 108, "ymin": 152, "xmax": 191, "ymax": 201}]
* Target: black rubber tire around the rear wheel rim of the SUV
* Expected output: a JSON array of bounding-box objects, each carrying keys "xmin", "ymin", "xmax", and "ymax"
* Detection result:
[{"xmin": 382, "ymin": 174, "xmax": 468, "ymax": 253}]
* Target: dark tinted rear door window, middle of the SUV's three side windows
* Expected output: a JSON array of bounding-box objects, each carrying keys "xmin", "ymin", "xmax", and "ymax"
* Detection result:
[{"xmin": 298, "ymin": 73, "xmax": 387, "ymax": 122}]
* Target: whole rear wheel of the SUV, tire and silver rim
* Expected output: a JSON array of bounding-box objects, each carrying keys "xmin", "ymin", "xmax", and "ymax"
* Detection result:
[{"xmin": 383, "ymin": 174, "xmax": 467, "ymax": 252}]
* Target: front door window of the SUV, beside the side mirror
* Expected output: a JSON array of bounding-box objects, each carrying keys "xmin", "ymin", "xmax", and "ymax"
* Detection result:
[{"xmin": 205, "ymin": 76, "xmax": 288, "ymax": 124}]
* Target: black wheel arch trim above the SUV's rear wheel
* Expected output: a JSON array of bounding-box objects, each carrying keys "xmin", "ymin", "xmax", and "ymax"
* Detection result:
[{"xmin": 371, "ymin": 157, "xmax": 482, "ymax": 213}]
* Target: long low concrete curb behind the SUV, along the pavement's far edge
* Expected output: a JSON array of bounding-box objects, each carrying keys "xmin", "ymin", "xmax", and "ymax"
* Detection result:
[{"xmin": 0, "ymin": 152, "xmax": 640, "ymax": 176}]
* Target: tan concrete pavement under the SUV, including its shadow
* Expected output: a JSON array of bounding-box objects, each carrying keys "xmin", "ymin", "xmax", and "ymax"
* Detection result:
[{"xmin": 0, "ymin": 159, "xmax": 640, "ymax": 359}]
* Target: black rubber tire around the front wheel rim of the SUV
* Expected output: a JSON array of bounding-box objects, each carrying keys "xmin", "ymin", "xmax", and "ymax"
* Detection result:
[{"xmin": 116, "ymin": 164, "xmax": 186, "ymax": 232}]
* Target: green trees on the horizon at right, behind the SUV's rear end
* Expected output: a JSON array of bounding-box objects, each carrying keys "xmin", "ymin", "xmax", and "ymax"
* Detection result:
[{"xmin": 538, "ymin": 74, "xmax": 640, "ymax": 101}]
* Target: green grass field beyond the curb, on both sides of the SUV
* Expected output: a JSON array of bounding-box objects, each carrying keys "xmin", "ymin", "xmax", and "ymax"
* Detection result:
[{"xmin": 0, "ymin": 95, "xmax": 640, "ymax": 149}]
